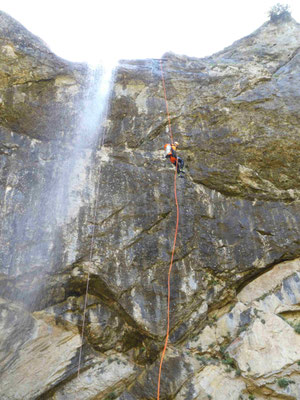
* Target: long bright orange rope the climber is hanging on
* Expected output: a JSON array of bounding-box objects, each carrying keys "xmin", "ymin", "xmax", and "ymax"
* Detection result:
[{"xmin": 157, "ymin": 60, "xmax": 179, "ymax": 400}]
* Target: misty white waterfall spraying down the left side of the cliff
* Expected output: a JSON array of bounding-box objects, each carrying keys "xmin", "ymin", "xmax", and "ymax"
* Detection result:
[{"xmin": 0, "ymin": 61, "xmax": 114, "ymax": 309}]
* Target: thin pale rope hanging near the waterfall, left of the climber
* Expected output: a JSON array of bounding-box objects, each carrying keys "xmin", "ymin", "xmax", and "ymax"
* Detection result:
[{"xmin": 77, "ymin": 103, "xmax": 105, "ymax": 377}]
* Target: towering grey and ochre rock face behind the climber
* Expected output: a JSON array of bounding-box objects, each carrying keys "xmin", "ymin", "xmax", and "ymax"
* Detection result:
[{"xmin": 0, "ymin": 9, "xmax": 300, "ymax": 400}]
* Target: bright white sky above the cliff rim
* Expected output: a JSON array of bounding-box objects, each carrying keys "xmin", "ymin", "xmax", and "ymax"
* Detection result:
[{"xmin": 0, "ymin": 0, "xmax": 300, "ymax": 64}]
